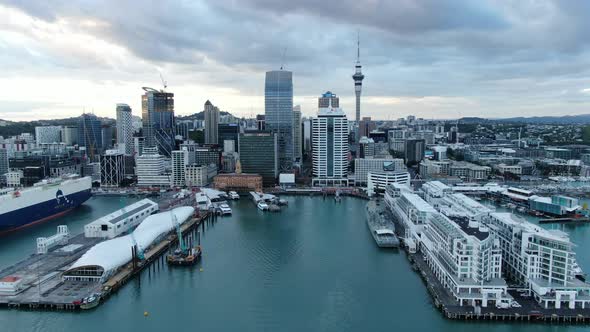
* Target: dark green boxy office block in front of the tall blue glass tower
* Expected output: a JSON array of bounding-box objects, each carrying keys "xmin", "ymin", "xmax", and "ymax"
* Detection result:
[{"xmin": 239, "ymin": 131, "xmax": 279, "ymax": 187}]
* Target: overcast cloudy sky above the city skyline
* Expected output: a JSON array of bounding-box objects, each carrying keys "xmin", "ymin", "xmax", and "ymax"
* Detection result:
[{"xmin": 0, "ymin": 0, "xmax": 590, "ymax": 120}]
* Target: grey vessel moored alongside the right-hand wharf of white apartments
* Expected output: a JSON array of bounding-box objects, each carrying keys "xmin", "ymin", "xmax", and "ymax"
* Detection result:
[{"xmin": 365, "ymin": 200, "xmax": 399, "ymax": 248}]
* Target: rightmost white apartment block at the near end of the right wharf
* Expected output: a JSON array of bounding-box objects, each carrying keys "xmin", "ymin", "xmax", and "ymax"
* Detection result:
[{"xmin": 486, "ymin": 213, "xmax": 590, "ymax": 309}]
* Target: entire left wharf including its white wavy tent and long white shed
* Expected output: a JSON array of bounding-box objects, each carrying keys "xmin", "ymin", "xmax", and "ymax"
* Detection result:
[{"xmin": 0, "ymin": 200, "xmax": 215, "ymax": 310}]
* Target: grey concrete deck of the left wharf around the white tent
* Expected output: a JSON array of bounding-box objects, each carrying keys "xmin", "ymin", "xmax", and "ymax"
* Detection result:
[{"xmin": 0, "ymin": 213, "xmax": 217, "ymax": 310}]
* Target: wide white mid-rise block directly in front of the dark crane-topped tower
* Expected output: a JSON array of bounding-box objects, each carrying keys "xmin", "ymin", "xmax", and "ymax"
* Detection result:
[{"xmin": 135, "ymin": 148, "xmax": 171, "ymax": 187}]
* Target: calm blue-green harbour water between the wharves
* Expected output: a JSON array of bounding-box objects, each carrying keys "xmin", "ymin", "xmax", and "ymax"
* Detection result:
[{"xmin": 0, "ymin": 197, "xmax": 590, "ymax": 332}]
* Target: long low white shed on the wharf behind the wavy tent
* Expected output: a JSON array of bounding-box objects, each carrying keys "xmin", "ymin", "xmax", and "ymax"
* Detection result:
[{"xmin": 84, "ymin": 199, "xmax": 159, "ymax": 239}]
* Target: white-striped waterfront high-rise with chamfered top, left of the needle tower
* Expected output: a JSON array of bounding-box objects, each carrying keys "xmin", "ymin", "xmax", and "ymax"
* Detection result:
[{"xmin": 312, "ymin": 101, "xmax": 348, "ymax": 186}]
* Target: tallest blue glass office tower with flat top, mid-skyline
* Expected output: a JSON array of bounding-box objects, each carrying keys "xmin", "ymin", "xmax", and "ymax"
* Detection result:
[{"xmin": 264, "ymin": 70, "xmax": 293, "ymax": 172}]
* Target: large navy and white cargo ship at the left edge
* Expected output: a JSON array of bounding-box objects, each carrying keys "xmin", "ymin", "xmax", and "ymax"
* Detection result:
[{"xmin": 0, "ymin": 177, "xmax": 92, "ymax": 235}]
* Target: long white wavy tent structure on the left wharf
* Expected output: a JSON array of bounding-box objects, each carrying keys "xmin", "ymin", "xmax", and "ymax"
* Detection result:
[{"xmin": 63, "ymin": 206, "xmax": 195, "ymax": 282}]
